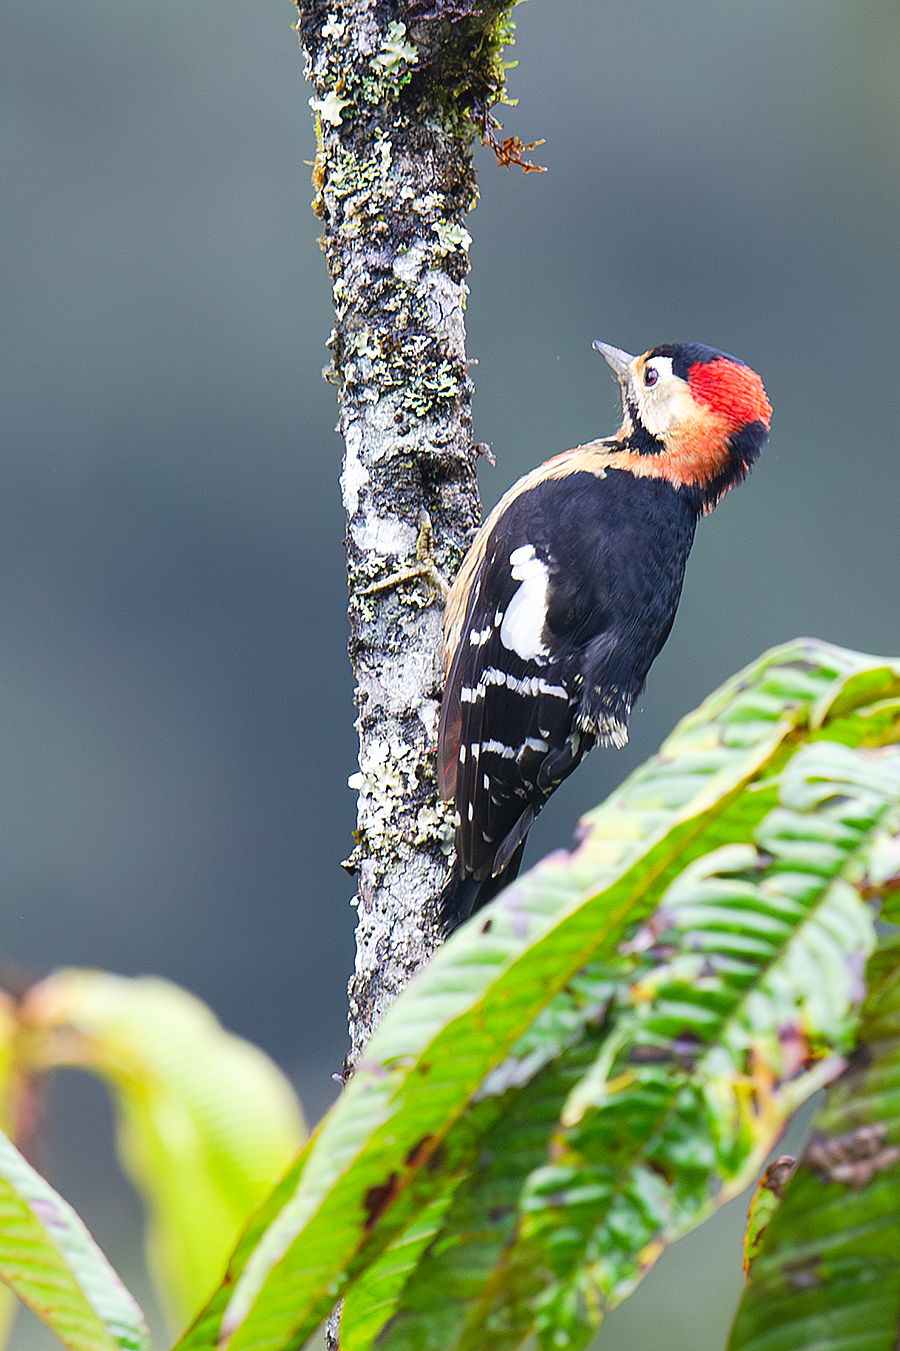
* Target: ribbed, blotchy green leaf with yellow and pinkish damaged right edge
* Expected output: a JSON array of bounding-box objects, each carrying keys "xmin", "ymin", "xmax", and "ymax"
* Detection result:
[{"xmin": 385, "ymin": 743, "xmax": 900, "ymax": 1351}]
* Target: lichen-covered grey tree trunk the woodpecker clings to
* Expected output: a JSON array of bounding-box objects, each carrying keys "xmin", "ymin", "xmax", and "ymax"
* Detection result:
[{"xmin": 297, "ymin": 0, "xmax": 512, "ymax": 1071}]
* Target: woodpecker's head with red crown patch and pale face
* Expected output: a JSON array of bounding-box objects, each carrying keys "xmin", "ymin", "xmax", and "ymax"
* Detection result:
[{"xmin": 593, "ymin": 342, "xmax": 772, "ymax": 511}]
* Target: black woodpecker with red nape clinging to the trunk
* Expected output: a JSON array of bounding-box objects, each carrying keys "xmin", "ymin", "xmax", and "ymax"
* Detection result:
[{"xmin": 438, "ymin": 342, "xmax": 772, "ymax": 934}]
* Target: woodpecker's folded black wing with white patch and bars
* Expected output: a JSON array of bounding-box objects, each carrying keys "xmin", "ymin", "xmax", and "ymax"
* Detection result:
[{"xmin": 439, "ymin": 534, "xmax": 581, "ymax": 881}]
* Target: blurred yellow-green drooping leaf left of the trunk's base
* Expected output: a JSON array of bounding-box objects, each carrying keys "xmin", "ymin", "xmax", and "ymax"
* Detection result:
[{"xmin": 26, "ymin": 970, "xmax": 304, "ymax": 1327}]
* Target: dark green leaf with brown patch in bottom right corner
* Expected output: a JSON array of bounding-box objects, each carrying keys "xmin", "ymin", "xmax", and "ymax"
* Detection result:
[{"xmin": 728, "ymin": 938, "xmax": 900, "ymax": 1351}]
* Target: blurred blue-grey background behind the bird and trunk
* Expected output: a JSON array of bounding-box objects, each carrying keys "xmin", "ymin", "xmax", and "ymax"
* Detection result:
[{"xmin": 0, "ymin": 0, "xmax": 900, "ymax": 1351}]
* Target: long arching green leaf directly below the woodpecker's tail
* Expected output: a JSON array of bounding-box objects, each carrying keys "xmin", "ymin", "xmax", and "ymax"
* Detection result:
[{"xmin": 177, "ymin": 642, "xmax": 900, "ymax": 1351}]
